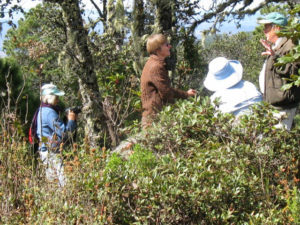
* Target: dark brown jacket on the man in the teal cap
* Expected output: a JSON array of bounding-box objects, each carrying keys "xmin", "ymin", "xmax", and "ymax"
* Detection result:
[{"xmin": 264, "ymin": 38, "xmax": 300, "ymax": 109}]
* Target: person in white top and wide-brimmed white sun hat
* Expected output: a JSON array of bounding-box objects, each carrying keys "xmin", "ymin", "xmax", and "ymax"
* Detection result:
[{"xmin": 204, "ymin": 57, "xmax": 262, "ymax": 118}]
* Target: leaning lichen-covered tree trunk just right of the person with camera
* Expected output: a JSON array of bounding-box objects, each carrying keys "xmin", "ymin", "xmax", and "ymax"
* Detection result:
[{"xmin": 48, "ymin": 0, "xmax": 105, "ymax": 147}]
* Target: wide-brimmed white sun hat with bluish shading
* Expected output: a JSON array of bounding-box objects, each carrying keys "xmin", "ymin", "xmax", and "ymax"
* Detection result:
[{"xmin": 204, "ymin": 57, "xmax": 243, "ymax": 91}]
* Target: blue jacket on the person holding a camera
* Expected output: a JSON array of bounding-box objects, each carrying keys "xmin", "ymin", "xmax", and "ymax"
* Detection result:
[{"xmin": 37, "ymin": 107, "xmax": 77, "ymax": 151}]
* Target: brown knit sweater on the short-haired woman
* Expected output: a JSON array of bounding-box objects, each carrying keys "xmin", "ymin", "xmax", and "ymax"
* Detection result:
[{"xmin": 141, "ymin": 55, "xmax": 188, "ymax": 118}]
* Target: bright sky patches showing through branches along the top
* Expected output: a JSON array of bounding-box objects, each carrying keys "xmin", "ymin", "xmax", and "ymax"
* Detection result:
[{"xmin": 0, "ymin": 0, "xmax": 264, "ymax": 57}]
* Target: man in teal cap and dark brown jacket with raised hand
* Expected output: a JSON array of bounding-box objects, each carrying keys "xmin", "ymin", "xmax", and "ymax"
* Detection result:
[{"xmin": 257, "ymin": 12, "xmax": 300, "ymax": 130}]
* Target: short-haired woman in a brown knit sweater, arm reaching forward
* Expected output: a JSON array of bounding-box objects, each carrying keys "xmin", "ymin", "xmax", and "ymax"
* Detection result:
[{"xmin": 141, "ymin": 34, "xmax": 196, "ymax": 128}]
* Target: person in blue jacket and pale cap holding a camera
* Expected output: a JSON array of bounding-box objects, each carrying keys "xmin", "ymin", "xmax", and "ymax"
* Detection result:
[{"xmin": 36, "ymin": 84, "xmax": 77, "ymax": 187}]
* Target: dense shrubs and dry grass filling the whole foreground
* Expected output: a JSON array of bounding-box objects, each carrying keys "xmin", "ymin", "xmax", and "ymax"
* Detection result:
[{"xmin": 0, "ymin": 98, "xmax": 300, "ymax": 224}]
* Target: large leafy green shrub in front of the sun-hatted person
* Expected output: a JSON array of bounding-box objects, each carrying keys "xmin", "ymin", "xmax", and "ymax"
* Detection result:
[{"xmin": 100, "ymin": 99, "xmax": 299, "ymax": 224}]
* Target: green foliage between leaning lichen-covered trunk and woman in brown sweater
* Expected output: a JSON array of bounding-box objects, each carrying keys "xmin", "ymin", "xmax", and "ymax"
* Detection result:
[{"xmin": 91, "ymin": 34, "xmax": 141, "ymax": 145}]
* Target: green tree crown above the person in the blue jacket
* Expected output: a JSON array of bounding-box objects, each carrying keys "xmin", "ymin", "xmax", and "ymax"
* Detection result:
[{"xmin": 3, "ymin": 4, "xmax": 66, "ymax": 88}]
